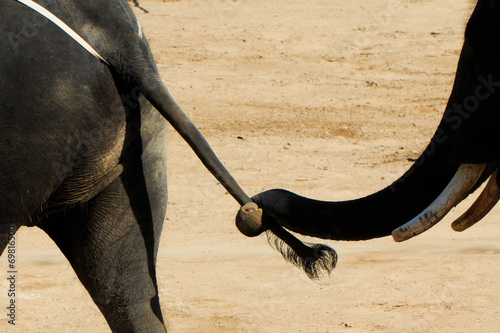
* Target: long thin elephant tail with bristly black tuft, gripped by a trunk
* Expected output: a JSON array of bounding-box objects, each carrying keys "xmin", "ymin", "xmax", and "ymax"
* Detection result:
[{"xmin": 97, "ymin": 30, "xmax": 337, "ymax": 279}]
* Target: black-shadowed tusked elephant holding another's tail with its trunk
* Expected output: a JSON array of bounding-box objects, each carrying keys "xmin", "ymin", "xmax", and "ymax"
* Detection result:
[{"xmin": 237, "ymin": 0, "xmax": 500, "ymax": 264}]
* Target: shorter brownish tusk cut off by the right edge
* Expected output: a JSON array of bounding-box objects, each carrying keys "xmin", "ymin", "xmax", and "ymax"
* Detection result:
[{"xmin": 451, "ymin": 169, "xmax": 500, "ymax": 231}]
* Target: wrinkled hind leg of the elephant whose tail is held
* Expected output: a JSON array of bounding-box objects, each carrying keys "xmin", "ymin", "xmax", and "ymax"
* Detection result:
[{"xmin": 41, "ymin": 175, "xmax": 166, "ymax": 332}]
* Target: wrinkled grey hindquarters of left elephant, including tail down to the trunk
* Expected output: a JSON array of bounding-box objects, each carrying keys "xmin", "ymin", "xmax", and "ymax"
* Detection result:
[{"xmin": 0, "ymin": 0, "xmax": 256, "ymax": 332}]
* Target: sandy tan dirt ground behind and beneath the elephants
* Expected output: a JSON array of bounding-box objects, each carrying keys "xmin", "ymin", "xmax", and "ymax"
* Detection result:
[{"xmin": 0, "ymin": 0, "xmax": 500, "ymax": 333}]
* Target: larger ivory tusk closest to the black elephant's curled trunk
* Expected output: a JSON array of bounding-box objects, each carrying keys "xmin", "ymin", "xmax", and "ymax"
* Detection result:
[{"xmin": 392, "ymin": 164, "xmax": 486, "ymax": 242}]
